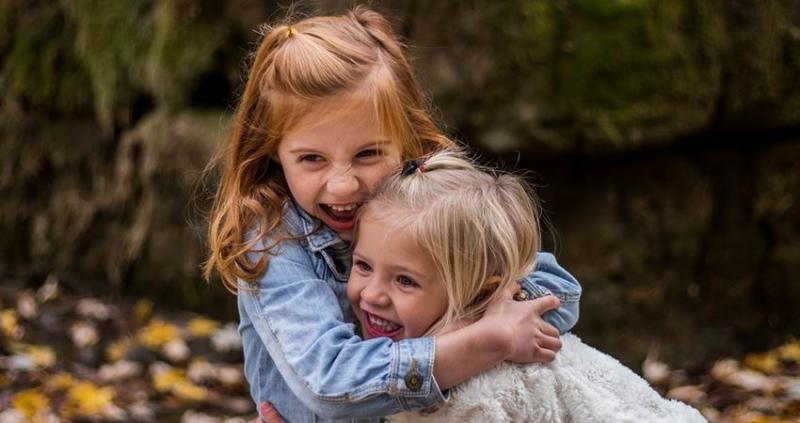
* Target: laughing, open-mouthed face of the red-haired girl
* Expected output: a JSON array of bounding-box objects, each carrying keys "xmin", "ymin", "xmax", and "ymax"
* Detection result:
[{"xmin": 278, "ymin": 97, "xmax": 400, "ymax": 241}]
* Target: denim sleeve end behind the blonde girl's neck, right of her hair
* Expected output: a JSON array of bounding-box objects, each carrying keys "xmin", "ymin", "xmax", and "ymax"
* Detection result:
[{"xmin": 522, "ymin": 252, "xmax": 581, "ymax": 334}]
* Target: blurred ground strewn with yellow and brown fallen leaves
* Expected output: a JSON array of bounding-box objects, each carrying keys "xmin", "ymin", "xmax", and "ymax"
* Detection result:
[{"xmin": 0, "ymin": 277, "xmax": 800, "ymax": 423}]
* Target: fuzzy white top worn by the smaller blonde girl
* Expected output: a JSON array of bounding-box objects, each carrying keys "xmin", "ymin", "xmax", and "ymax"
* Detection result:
[{"xmin": 389, "ymin": 334, "xmax": 706, "ymax": 423}]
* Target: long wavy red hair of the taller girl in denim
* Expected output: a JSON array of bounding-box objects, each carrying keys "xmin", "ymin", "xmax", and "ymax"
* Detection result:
[{"xmin": 204, "ymin": 6, "xmax": 455, "ymax": 292}]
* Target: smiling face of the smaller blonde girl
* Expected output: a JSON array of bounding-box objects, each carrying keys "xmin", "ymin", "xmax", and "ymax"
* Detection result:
[{"xmin": 347, "ymin": 215, "xmax": 447, "ymax": 340}]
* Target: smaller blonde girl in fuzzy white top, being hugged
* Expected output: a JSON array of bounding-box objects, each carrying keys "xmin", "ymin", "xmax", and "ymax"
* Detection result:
[{"xmin": 348, "ymin": 152, "xmax": 705, "ymax": 423}]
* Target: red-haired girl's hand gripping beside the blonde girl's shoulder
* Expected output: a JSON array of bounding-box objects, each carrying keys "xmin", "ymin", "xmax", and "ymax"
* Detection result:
[{"xmin": 478, "ymin": 284, "xmax": 561, "ymax": 363}]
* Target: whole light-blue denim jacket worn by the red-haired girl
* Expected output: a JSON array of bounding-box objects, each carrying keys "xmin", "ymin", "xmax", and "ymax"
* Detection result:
[{"xmin": 238, "ymin": 201, "xmax": 581, "ymax": 422}]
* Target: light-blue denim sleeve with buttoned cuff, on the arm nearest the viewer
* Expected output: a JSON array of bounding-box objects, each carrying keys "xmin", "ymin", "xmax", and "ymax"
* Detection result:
[{"xmin": 238, "ymin": 241, "xmax": 444, "ymax": 419}]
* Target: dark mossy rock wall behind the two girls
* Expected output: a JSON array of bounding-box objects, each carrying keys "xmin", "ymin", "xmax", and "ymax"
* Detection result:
[{"xmin": 0, "ymin": 0, "xmax": 800, "ymax": 364}]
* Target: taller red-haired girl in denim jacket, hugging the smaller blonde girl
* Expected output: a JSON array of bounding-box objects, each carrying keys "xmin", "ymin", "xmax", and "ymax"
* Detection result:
[{"xmin": 206, "ymin": 7, "xmax": 577, "ymax": 421}]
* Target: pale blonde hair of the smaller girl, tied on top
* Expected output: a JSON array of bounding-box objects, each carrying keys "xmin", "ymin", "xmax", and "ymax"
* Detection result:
[{"xmin": 356, "ymin": 151, "xmax": 540, "ymax": 333}]
